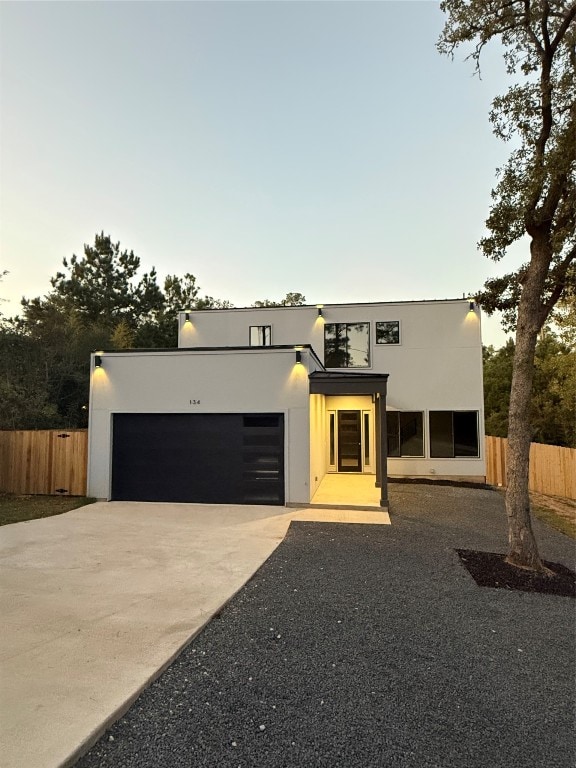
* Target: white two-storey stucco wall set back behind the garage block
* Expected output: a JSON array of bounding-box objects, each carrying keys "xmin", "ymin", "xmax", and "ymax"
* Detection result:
[{"xmin": 179, "ymin": 299, "xmax": 486, "ymax": 478}]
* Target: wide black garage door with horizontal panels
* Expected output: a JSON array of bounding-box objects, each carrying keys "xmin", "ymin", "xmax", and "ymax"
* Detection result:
[{"xmin": 112, "ymin": 413, "xmax": 284, "ymax": 504}]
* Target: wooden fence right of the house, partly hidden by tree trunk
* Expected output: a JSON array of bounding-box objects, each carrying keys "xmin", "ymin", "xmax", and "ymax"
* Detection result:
[{"xmin": 486, "ymin": 437, "xmax": 576, "ymax": 499}]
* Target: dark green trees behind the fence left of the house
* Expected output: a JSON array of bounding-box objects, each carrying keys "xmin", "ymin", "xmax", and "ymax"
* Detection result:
[{"xmin": 0, "ymin": 233, "xmax": 230, "ymax": 429}]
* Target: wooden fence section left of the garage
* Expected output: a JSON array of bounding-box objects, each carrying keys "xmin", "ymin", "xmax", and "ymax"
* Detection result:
[{"xmin": 0, "ymin": 429, "xmax": 88, "ymax": 496}]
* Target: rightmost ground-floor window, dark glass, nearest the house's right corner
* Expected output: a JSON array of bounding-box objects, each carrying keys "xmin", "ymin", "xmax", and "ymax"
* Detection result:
[{"xmin": 430, "ymin": 411, "xmax": 479, "ymax": 459}]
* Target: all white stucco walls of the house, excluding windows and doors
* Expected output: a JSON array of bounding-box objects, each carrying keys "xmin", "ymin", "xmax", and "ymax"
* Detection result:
[{"xmin": 88, "ymin": 300, "xmax": 485, "ymax": 503}]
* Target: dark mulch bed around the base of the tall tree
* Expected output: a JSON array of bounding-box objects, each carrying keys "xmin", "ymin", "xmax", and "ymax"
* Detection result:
[{"xmin": 456, "ymin": 549, "xmax": 576, "ymax": 597}]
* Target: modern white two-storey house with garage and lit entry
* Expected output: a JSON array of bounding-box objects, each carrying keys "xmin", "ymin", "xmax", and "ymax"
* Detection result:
[{"xmin": 88, "ymin": 299, "xmax": 486, "ymax": 507}]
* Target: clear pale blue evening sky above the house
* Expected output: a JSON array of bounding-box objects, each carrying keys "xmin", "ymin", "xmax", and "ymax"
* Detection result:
[{"xmin": 0, "ymin": 0, "xmax": 526, "ymax": 346}]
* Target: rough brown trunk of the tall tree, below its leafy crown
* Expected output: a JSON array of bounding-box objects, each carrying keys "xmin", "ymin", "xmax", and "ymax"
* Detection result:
[{"xmin": 506, "ymin": 239, "xmax": 550, "ymax": 572}]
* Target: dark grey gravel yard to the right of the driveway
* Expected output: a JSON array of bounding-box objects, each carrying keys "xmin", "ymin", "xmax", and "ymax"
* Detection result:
[{"xmin": 77, "ymin": 485, "xmax": 576, "ymax": 768}]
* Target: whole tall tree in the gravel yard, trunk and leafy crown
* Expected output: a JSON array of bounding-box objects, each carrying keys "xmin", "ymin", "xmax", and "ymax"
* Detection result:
[{"xmin": 438, "ymin": 0, "xmax": 576, "ymax": 571}]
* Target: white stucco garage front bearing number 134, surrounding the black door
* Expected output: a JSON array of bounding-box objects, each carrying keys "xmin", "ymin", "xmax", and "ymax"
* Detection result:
[{"xmin": 88, "ymin": 349, "xmax": 313, "ymax": 503}]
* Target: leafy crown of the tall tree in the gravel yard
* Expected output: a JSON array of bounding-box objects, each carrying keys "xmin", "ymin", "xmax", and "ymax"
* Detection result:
[{"xmin": 438, "ymin": 0, "xmax": 576, "ymax": 328}]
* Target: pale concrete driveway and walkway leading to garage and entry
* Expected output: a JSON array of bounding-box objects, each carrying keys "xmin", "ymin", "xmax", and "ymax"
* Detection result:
[{"xmin": 0, "ymin": 502, "xmax": 390, "ymax": 768}]
